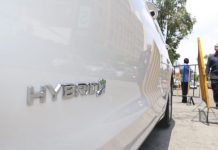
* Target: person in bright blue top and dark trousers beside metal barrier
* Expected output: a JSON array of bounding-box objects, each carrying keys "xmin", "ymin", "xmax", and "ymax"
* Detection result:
[{"xmin": 180, "ymin": 58, "xmax": 190, "ymax": 103}]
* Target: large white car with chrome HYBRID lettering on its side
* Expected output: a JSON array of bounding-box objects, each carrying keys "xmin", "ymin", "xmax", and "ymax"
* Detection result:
[{"xmin": 0, "ymin": 0, "xmax": 172, "ymax": 150}]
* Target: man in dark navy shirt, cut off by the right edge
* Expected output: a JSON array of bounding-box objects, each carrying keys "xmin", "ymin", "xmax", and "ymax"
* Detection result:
[{"xmin": 206, "ymin": 44, "xmax": 218, "ymax": 107}]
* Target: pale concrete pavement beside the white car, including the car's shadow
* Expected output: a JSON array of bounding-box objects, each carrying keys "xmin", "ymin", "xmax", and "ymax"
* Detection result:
[{"xmin": 140, "ymin": 90, "xmax": 218, "ymax": 150}]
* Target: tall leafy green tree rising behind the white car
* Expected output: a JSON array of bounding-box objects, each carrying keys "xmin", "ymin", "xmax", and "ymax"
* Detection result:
[{"xmin": 155, "ymin": 0, "xmax": 196, "ymax": 63}]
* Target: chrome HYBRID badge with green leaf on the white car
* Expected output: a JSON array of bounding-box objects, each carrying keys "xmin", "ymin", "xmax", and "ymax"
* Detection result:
[{"xmin": 27, "ymin": 79, "xmax": 106, "ymax": 106}]
